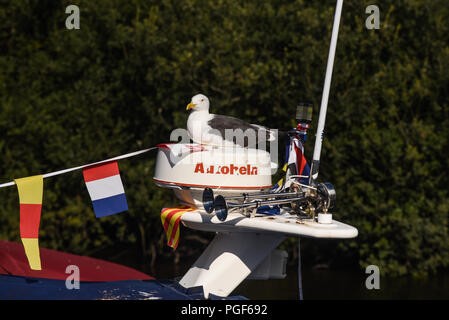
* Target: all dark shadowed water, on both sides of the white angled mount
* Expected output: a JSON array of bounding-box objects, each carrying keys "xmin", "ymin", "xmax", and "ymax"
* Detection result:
[{"xmin": 92, "ymin": 245, "xmax": 449, "ymax": 300}]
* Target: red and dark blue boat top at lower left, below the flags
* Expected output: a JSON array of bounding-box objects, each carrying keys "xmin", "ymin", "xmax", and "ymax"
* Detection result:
[{"xmin": 0, "ymin": 240, "xmax": 242, "ymax": 300}]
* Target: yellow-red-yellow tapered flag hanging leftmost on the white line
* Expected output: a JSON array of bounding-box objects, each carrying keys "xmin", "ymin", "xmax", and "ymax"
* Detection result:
[{"xmin": 14, "ymin": 175, "xmax": 44, "ymax": 270}]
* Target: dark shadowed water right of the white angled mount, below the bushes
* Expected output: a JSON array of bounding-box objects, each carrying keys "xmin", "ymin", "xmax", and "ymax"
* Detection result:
[{"xmin": 237, "ymin": 268, "xmax": 449, "ymax": 300}]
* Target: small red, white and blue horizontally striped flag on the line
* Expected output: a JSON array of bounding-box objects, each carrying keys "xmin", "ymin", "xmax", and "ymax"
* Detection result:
[{"xmin": 83, "ymin": 161, "xmax": 128, "ymax": 218}]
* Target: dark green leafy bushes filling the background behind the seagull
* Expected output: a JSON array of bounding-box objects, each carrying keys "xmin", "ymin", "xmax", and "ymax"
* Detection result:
[{"xmin": 0, "ymin": 0, "xmax": 449, "ymax": 275}]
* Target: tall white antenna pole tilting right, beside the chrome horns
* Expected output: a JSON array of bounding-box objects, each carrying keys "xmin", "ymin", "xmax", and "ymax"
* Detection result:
[{"xmin": 309, "ymin": 0, "xmax": 343, "ymax": 184}]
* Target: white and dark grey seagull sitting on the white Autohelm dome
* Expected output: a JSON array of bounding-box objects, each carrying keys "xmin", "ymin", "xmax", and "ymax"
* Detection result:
[{"xmin": 186, "ymin": 94, "xmax": 276, "ymax": 148}]
